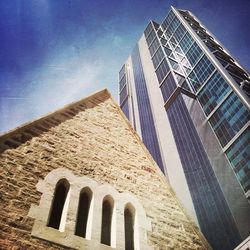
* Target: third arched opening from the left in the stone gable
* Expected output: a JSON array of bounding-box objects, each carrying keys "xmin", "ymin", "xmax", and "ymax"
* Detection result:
[{"xmin": 101, "ymin": 196, "xmax": 114, "ymax": 246}]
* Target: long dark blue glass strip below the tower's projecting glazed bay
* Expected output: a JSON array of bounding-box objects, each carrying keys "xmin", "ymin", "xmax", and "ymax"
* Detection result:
[{"xmin": 167, "ymin": 95, "xmax": 240, "ymax": 250}]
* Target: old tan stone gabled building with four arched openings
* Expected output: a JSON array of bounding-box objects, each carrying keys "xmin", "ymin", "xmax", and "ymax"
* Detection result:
[{"xmin": 0, "ymin": 90, "xmax": 210, "ymax": 250}]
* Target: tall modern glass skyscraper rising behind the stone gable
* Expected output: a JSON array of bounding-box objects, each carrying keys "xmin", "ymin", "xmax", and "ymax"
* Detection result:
[{"xmin": 119, "ymin": 7, "xmax": 250, "ymax": 250}]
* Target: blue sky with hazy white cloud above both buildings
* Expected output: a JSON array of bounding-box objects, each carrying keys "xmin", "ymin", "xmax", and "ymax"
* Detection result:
[{"xmin": 0, "ymin": 0, "xmax": 250, "ymax": 133}]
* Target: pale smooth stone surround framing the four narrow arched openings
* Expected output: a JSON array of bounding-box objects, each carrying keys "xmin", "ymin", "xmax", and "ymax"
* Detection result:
[{"xmin": 28, "ymin": 168, "xmax": 151, "ymax": 250}]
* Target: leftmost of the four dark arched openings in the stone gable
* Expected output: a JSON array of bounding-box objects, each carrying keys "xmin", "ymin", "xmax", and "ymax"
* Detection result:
[{"xmin": 47, "ymin": 179, "xmax": 70, "ymax": 229}]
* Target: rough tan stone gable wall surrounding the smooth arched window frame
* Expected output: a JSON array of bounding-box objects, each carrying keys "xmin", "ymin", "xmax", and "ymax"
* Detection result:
[{"xmin": 0, "ymin": 90, "xmax": 209, "ymax": 250}]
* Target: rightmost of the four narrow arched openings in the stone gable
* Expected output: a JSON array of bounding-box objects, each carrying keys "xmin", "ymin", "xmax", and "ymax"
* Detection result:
[{"xmin": 124, "ymin": 204, "xmax": 135, "ymax": 250}]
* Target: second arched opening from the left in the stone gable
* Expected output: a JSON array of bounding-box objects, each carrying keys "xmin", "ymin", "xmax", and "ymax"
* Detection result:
[{"xmin": 75, "ymin": 188, "xmax": 92, "ymax": 238}]
